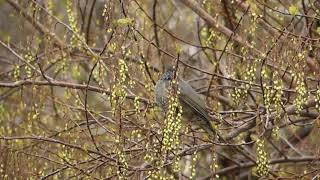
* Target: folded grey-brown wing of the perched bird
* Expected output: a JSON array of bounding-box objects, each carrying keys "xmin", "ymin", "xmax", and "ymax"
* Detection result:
[{"xmin": 179, "ymin": 80, "xmax": 211, "ymax": 121}]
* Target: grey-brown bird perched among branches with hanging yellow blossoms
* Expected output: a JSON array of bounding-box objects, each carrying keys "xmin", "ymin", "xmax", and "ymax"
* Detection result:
[{"xmin": 155, "ymin": 67, "xmax": 215, "ymax": 137}]
